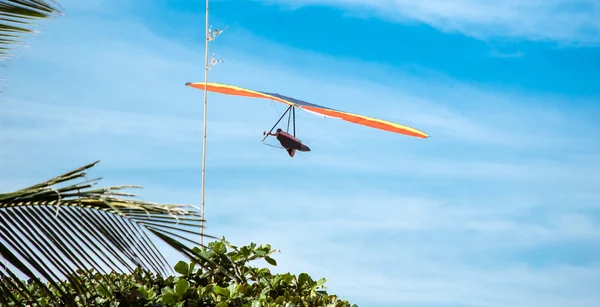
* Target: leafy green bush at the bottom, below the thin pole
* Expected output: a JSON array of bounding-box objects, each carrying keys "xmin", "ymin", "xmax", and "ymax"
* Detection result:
[{"xmin": 0, "ymin": 239, "xmax": 356, "ymax": 307}]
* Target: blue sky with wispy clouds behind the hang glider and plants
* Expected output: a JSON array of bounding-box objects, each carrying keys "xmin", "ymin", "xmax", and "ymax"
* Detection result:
[{"xmin": 0, "ymin": 0, "xmax": 600, "ymax": 307}]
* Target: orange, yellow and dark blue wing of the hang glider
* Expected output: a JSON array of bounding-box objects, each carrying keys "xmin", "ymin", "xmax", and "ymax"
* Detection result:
[{"xmin": 185, "ymin": 82, "xmax": 429, "ymax": 138}]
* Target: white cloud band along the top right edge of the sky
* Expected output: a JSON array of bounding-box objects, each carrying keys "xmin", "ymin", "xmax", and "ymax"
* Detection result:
[{"xmin": 262, "ymin": 0, "xmax": 600, "ymax": 45}]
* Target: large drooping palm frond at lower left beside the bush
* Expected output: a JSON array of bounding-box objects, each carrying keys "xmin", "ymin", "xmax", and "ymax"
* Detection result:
[{"xmin": 0, "ymin": 161, "xmax": 214, "ymax": 306}]
